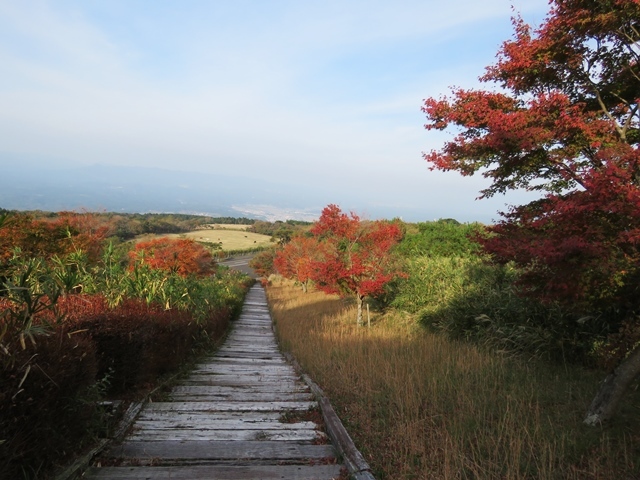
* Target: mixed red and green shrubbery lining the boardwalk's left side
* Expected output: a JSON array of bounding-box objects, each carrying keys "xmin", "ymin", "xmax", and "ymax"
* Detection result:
[{"xmin": 0, "ymin": 259, "xmax": 251, "ymax": 479}]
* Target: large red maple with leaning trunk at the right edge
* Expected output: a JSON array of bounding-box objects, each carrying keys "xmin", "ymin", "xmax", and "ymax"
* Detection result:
[{"xmin": 423, "ymin": 0, "xmax": 640, "ymax": 424}]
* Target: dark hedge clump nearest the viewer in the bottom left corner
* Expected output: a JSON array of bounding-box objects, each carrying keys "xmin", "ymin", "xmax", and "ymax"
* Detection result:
[{"xmin": 0, "ymin": 326, "xmax": 100, "ymax": 479}]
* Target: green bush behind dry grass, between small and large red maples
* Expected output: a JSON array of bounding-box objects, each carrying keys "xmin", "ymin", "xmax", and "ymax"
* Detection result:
[{"xmin": 392, "ymin": 255, "xmax": 607, "ymax": 361}]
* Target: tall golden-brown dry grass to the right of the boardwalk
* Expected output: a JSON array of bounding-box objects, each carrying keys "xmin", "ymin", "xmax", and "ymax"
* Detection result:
[{"xmin": 267, "ymin": 284, "xmax": 640, "ymax": 479}]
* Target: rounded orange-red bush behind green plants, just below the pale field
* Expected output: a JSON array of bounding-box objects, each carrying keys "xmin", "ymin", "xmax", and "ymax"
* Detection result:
[{"xmin": 129, "ymin": 237, "xmax": 214, "ymax": 276}]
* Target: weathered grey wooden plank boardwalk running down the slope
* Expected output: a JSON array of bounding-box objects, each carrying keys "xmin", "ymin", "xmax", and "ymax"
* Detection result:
[{"xmin": 85, "ymin": 285, "xmax": 341, "ymax": 480}]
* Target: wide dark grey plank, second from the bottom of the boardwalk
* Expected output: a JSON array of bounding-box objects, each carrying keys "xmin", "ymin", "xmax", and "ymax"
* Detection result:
[{"xmin": 109, "ymin": 440, "xmax": 335, "ymax": 462}]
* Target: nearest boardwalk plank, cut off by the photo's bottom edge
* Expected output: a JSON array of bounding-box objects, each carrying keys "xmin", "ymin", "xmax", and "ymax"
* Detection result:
[{"xmin": 89, "ymin": 464, "xmax": 340, "ymax": 480}]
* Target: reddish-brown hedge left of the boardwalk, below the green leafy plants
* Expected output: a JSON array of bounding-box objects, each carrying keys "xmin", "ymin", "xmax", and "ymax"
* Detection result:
[{"xmin": 0, "ymin": 294, "xmax": 231, "ymax": 478}]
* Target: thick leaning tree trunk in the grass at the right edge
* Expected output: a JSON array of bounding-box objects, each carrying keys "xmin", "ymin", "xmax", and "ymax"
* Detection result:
[{"xmin": 584, "ymin": 346, "xmax": 640, "ymax": 426}]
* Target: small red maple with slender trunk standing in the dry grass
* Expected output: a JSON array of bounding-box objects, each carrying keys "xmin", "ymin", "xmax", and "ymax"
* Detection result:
[{"xmin": 307, "ymin": 205, "xmax": 402, "ymax": 325}]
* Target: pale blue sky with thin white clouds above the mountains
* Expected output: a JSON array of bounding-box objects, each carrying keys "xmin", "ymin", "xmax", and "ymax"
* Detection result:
[{"xmin": 0, "ymin": 0, "xmax": 548, "ymax": 222}]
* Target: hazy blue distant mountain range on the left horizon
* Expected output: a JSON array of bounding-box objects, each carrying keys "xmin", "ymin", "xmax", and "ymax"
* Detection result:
[{"xmin": 0, "ymin": 163, "xmax": 323, "ymax": 220}]
